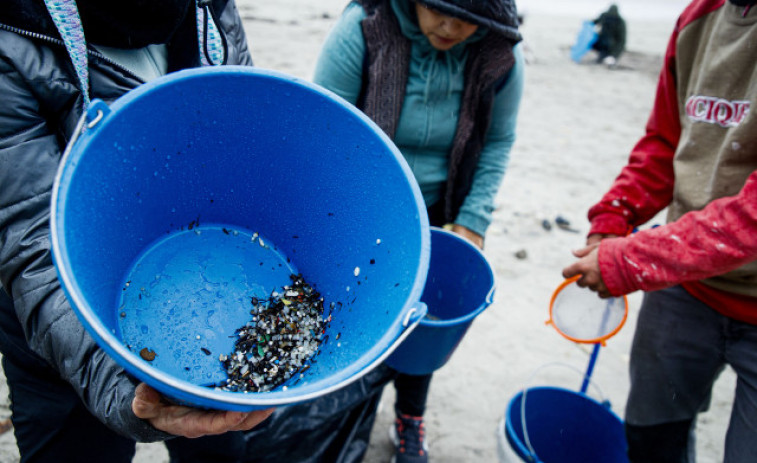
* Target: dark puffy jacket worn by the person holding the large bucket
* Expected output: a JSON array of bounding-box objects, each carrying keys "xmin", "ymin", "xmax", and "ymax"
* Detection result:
[{"xmin": 0, "ymin": 0, "xmax": 252, "ymax": 441}]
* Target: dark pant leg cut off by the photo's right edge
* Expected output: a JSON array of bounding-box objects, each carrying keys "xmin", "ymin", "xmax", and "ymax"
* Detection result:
[{"xmin": 724, "ymin": 320, "xmax": 757, "ymax": 463}]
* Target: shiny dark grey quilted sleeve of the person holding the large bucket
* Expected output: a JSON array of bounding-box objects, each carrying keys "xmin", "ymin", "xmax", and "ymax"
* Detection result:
[{"xmin": 0, "ymin": 32, "xmax": 169, "ymax": 441}]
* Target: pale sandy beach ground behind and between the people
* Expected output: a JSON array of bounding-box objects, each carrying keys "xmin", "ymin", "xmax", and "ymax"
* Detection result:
[{"xmin": 0, "ymin": 0, "xmax": 735, "ymax": 463}]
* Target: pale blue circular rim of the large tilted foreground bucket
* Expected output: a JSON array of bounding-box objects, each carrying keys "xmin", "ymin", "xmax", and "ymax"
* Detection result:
[{"xmin": 50, "ymin": 65, "xmax": 431, "ymax": 411}]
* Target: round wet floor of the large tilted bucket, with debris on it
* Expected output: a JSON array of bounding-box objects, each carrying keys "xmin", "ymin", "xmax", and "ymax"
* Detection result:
[{"xmin": 119, "ymin": 225, "xmax": 328, "ymax": 391}]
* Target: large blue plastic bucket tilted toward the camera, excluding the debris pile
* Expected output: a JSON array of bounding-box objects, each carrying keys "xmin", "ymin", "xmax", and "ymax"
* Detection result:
[{"xmin": 52, "ymin": 66, "xmax": 430, "ymax": 410}]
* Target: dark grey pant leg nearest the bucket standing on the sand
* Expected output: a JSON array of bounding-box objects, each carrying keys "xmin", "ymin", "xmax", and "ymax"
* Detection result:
[{"xmin": 626, "ymin": 286, "xmax": 728, "ymax": 462}]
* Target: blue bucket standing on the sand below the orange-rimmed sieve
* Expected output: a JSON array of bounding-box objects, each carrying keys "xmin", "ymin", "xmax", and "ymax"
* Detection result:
[{"xmin": 504, "ymin": 387, "xmax": 628, "ymax": 463}]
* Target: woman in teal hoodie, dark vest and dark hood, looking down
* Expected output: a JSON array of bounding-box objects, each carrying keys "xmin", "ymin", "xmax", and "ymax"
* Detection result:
[{"xmin": 314, "ymin": 0, "xmax": 524, "ymax": 463}]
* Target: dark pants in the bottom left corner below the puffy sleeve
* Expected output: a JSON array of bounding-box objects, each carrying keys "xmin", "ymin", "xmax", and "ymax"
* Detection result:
[{"xmin": 2, "ymin": 357, "xmax": 136, "ymax": 463}]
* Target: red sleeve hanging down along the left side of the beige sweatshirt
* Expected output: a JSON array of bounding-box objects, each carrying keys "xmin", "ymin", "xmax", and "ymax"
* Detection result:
[{"xmin": 588, "ymin": 0, "xmax": 725, "ymax": 236}]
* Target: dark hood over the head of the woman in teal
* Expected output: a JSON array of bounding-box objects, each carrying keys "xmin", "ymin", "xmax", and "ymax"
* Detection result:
[{"xmin": 414, "ymin": 0, "xmax": 522, "ymax": 42}]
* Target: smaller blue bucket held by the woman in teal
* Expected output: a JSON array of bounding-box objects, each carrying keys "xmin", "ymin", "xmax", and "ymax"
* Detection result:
[{"xmin": 386, "ymin": 227, "xmax": 495, "ymax": 375}]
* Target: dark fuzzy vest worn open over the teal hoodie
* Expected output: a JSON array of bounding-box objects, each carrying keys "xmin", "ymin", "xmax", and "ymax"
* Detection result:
[{"xmin": 357, "ymin": 0, "xmax": 515, "ymax": 222}]
